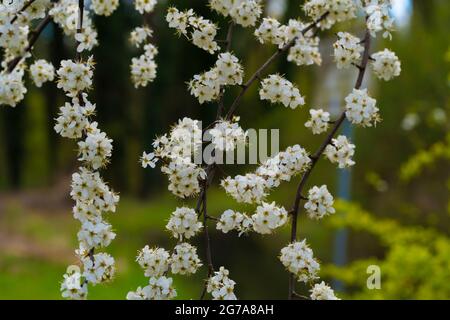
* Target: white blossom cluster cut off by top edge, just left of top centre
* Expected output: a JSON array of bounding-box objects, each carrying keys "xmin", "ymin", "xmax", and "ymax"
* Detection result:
[{"xmin": 209, "ymin": 0, "xmax": 262, "ymax": 27}]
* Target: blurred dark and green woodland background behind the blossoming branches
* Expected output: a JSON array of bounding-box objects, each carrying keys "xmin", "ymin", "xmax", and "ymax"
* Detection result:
[{"xmin": 0, "ymin": 0, "xmax": 450, "ymax": 299}]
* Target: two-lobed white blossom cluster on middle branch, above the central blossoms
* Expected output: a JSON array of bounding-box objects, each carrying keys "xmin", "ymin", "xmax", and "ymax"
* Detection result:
[{"xmin": 189, "ymin": 52, "xmax": 244, "ymax": 103}]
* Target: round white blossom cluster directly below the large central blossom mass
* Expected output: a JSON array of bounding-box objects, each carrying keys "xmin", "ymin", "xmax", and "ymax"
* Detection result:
[{"xmin": 166, "ymin": 207, "xmax": 203, "ymax": 240}]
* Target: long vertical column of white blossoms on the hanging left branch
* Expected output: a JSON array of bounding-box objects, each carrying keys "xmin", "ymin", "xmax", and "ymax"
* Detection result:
[{"xmin": 58, "ymin": 21, "xmax": 119, "ymax": 299}]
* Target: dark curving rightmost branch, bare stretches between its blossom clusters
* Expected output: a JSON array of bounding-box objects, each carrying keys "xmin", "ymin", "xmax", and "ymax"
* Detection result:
[{"xmin": 288, "ymin": 25, "xmax": 370, "ymax": 299}]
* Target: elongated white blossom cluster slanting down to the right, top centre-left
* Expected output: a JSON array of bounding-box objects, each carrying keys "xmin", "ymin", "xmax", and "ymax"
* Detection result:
[{"xmin": 166, "ymin": 7, "xmax": 219, "ymax": 54}]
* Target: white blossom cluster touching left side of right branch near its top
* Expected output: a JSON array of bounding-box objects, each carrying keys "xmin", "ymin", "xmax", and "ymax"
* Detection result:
[{"xmin": 333, "ymin": 32, "xmax": 364, "ymax": 69}]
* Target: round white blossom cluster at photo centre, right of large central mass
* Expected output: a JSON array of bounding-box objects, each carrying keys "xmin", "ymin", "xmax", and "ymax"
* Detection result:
[{"xmin": 209, "ymin": 120, "xmax": 247, "ymax": 151}]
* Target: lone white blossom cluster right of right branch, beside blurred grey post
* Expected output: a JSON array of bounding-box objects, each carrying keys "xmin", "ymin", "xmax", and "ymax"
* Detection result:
[{"xmin": 305, "ymin": 185, "xmax": 335, "ymax": 219}]
